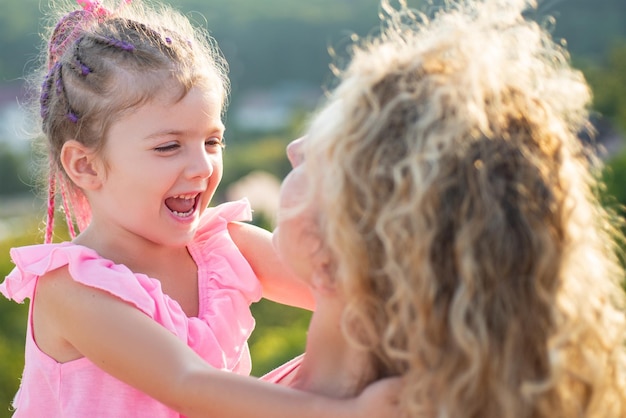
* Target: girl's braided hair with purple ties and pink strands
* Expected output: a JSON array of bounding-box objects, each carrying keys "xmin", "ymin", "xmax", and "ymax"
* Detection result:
[{"xmin": 31, "ymin": 1, "xmax": 229, "ymax": 240}]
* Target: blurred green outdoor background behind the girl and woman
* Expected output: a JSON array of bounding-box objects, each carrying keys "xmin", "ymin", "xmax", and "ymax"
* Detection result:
[{"xmin": 0, "ymin": 0, "xmax": 626, "ymax": 418}]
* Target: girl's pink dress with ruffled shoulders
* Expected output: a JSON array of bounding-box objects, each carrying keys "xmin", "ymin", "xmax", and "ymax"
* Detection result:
[{"xmin": 0, "ymin": 200, "xmax": 261, "ymax": 418}]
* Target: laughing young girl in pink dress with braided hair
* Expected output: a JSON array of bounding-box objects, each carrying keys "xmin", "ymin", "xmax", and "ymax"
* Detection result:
[{"xmin": 0, "ymin": 2, "xmax": 393, "ymax": 418}]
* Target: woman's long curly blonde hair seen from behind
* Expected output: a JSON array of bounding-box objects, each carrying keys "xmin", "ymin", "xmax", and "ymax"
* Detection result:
[{"xmin": 304, "ymin": 0, "xmax": 626, "ymax": 418}]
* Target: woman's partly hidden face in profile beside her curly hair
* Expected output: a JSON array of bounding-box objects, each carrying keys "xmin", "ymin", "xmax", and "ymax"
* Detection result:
[{"xmin": 273, "ymin": 138, "xmax": 322, "ymax": 281}]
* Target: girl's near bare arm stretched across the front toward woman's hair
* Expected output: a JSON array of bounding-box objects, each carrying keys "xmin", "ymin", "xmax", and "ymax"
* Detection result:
[{"xmin": 34, "ymin": 267, "xmax": 397, "ymax": 418}]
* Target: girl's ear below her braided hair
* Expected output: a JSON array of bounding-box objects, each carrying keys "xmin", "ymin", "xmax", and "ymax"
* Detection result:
[{"xmin": 61, "ymin": 139, "xmax": 103, "ymax": 190}]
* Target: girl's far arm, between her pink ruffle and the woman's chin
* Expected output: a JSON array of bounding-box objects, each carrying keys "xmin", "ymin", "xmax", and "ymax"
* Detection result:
[{"xmin": 228, "ymin": 222, "xmax": 315, "ymax": 310}]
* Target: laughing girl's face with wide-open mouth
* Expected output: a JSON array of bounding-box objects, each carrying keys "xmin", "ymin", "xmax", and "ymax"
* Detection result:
[{"xmin": 90, "ymin": 88, "xmax": 224, "ymax": 246}]
